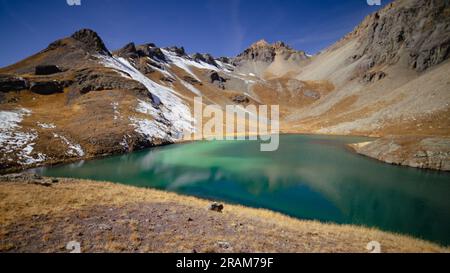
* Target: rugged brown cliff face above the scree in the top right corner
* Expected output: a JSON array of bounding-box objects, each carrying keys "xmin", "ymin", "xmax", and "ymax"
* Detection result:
[{"xmin": 354, "ymin": 0, "xmax": 450, "ymax": 72}]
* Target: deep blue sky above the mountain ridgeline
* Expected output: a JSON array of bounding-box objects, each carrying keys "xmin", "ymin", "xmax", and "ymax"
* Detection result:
[{"xmin": 0, "ymin": 0, "xmax": 390, "ymax": 67}]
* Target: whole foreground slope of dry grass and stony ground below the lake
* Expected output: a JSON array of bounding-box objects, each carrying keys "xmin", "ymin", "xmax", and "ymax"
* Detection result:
[{"xmin": 0, "ymin": 177, "xmax": 448, "ymax": 252}]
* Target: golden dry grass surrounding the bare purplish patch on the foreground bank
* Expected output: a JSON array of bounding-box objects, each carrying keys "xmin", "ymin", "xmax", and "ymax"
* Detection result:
[{"xmin": 0, "ymin": 179, "xmax": 449, "ymax": 252}]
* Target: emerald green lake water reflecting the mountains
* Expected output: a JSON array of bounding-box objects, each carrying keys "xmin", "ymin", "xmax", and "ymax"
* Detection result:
[{"xmin": 35, "ymin": 135, "xmax": 450, "ymax": 245}]
